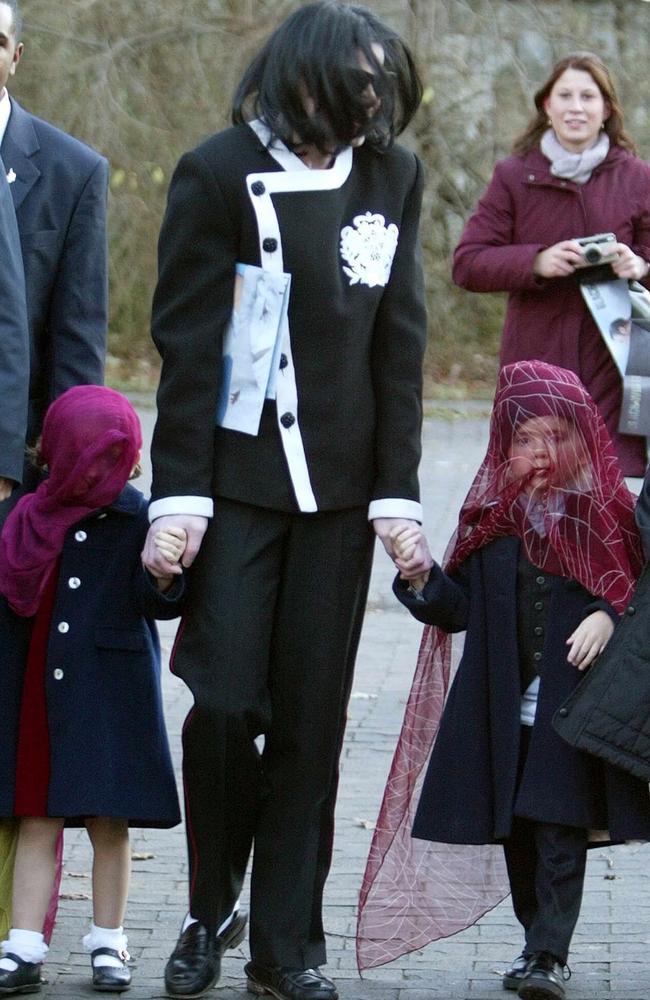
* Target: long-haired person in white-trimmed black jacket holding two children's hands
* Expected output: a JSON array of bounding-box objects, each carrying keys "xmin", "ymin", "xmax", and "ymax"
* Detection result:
[{"xmin": 144, "ymin": 0, "xmax": 429, "ymax": 1000}]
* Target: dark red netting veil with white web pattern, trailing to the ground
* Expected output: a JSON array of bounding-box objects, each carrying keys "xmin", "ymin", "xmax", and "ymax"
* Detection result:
[{"xmin": 357, "ymin": 361, "xmax": 643, "ymax": 970}]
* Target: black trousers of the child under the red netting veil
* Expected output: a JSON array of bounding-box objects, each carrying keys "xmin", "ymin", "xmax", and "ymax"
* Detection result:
[{"xmin": 504, "ymin": 726, "xmax": 587, "ymax": 964}]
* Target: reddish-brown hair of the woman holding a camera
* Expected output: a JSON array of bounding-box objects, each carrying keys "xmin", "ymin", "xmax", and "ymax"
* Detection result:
[{"xmin": 512, "ymin": 52, "xmax": 636, "ymax": 154}]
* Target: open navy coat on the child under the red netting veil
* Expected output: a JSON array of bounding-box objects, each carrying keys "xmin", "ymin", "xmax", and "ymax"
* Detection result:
[{"xmin": 395, "ymin": 538, "xmax": 650, "ymax": 844}]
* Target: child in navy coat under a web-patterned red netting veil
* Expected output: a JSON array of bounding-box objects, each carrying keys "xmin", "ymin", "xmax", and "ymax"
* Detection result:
[{"xmin": 357, "ymin": 361, "xmax": 650, "ymax": 1000}]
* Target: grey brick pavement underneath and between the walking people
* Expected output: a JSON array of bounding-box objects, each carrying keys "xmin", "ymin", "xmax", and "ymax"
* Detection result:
[{"xmin": 36, "ymin": 400, "xmax": 650, "ymax": 1000}]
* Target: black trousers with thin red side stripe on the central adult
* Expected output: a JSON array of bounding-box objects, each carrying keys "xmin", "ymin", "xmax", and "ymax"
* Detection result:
[{"xmin": 173, "ymin": 499, "xmax": 373, "ymax": 968}]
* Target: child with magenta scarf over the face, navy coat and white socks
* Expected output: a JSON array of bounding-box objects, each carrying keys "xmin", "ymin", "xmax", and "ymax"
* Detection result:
[{"xmin": 0, "ymin": 386, "xmax": 185, "ymax": 994}]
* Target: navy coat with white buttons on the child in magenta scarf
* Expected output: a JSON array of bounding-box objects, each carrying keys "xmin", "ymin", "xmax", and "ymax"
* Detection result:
[{"xmin": 0, "ymin": 486, "xmax": 183, "ymax": 827}]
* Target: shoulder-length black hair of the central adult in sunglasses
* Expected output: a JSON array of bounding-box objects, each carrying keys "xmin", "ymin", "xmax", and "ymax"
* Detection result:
[{"xmin": 232, "ymin": 0, "xmax": 422, "ymax": 153}]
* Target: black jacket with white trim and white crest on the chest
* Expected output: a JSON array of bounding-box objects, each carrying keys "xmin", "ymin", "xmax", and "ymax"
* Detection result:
[{"xmin": 152, "ymin": 125, "xmax": 426, "ymax": 511}]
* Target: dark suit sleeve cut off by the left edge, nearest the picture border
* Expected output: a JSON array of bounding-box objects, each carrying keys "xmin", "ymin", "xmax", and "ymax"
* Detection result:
[{"xmin": 0, "ymin": 159, "xmax": 29, "ymax": 482}]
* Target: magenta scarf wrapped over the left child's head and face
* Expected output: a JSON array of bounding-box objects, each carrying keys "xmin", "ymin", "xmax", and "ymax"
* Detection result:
[{"xmin": 0, "ymin": 385, "xmax": 142, "ymax": 616}]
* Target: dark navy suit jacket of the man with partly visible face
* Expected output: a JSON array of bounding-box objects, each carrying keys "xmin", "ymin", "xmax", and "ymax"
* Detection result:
[{"xmin": 0, "ymin": 99, "xmax": 108, "ymax": 439}]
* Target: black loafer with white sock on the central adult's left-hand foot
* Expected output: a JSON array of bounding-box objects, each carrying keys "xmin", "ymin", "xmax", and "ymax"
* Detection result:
[{"xmin": 165, "ymin": 912, "xmax": 248, "ymax": 998}]
